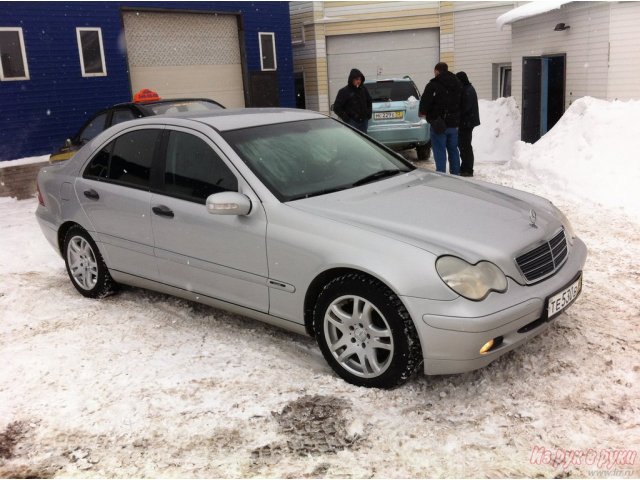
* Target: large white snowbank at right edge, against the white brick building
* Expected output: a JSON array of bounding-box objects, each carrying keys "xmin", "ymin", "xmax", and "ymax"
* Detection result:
[{"xmin": 508, "ymin": 97, "xmax": 640, "ymax": 221}]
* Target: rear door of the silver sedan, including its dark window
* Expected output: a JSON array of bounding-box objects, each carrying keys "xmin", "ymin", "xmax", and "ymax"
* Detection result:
[{"xmin": 75, "ymin": 127, "xmax": 162, "ymax": 279}]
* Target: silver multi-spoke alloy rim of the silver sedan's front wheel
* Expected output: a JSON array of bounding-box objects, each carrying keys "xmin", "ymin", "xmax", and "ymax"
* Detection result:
[{"xmin": 324, "ymin": 295, "xmax": 393, "ymax": 378}]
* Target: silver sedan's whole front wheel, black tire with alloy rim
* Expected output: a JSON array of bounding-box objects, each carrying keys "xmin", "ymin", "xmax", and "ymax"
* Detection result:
[{"xmin": 313, "ymin": 273, "xmax": 422, "ymax": 388}]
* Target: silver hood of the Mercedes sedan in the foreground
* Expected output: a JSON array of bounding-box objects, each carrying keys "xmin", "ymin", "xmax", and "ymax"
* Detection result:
[{"xmin": 289, "ymin": 170, "xmax": 562, "ymax": 278}]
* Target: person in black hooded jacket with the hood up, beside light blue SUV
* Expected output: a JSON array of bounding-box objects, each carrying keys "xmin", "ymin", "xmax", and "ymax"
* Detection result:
[{"xmin": 333, "ymin": 68, "xmax": 372, "ymax": 133}]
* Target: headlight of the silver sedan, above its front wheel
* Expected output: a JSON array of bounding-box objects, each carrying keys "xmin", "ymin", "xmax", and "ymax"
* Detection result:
[{"xmin": 436, "ymin": 255, "xmax": 507, "ymax": 300}]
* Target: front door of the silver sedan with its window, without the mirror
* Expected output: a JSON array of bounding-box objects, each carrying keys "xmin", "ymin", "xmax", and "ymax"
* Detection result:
[{"xmin": 151, "ymin": 128, "xmax": 269, "ymax": 312}]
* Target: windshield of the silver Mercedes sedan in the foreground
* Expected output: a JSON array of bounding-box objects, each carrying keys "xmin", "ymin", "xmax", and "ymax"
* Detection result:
[{"xmin": 223, "ymin": 118, "xmax": 414, "ymax": 202}]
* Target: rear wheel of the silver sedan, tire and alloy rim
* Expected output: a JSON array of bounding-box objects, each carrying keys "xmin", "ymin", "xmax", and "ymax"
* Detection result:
[{"xmin": 64, "ymin": 226, "xmax": 115, "ymax": 298}]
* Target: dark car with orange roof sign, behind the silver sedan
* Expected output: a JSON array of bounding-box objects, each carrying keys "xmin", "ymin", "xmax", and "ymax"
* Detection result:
[{"xmin": 49, "ymin": 89, "xmax": 224, "ymax": 162}]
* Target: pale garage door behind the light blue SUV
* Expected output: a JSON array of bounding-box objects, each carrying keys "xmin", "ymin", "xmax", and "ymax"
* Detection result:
[{"xmin": 327, "ymin": 28, "xmax": 440, "ymax": 103}]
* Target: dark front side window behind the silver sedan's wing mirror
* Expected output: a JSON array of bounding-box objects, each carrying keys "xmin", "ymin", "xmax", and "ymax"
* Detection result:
[{"xmin": 164, "ymin": 131, "xmax": 238, "ymax": 203}]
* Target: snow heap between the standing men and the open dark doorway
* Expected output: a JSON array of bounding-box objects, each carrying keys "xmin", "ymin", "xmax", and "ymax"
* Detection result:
[{"xmin": 472, "ymin": 97, "xmax": 520, "ymax": 163}]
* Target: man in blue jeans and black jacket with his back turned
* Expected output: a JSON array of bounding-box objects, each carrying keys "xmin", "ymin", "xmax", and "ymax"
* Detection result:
[{"xmin": 420, "ymin": 62, "xmax": 462, "ymax": 175}]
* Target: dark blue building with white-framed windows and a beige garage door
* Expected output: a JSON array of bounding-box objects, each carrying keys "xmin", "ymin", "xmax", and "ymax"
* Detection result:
[{"xmin": 0, "ymin": 1, "xmax": 295, "ymax": 160}]
